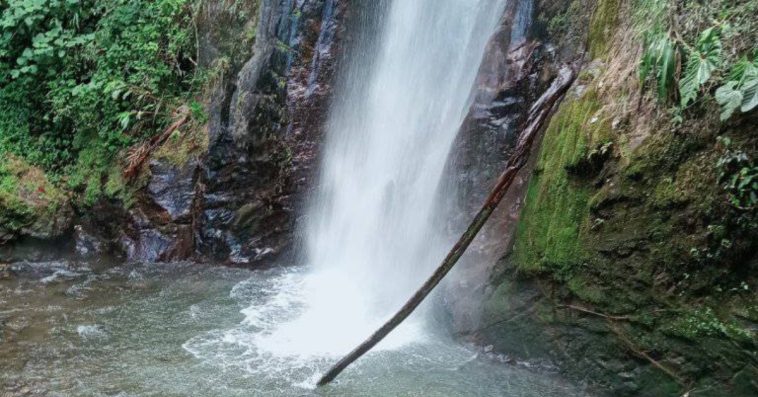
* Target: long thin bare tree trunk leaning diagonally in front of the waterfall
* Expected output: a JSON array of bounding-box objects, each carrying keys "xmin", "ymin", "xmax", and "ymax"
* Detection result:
[{"xmin": 318, "ymin": 66, "xmax": 575, "ymax": 386}]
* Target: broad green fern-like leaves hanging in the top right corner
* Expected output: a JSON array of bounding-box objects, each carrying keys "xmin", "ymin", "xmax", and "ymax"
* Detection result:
[{"xmin": 635, "ymin": 0, "xmax": 758, "ymax": 121}]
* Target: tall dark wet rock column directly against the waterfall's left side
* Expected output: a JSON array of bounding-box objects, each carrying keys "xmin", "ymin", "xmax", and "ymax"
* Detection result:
[{"xmin": 196, "ymin": 0, "xmax": 346, "ymax": 266}]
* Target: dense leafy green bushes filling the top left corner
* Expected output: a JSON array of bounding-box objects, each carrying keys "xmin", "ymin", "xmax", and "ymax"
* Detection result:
[{"xmin": 0, "ymin": 0, "xmax": 205, "ymax": 201}]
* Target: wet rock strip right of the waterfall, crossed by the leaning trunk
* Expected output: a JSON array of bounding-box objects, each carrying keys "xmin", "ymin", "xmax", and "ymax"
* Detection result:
[{"xmin": 445, "ymin": 0, "xmax": 557, "ymax": 333}]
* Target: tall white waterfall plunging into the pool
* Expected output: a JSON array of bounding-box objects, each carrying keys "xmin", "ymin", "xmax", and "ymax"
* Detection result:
[{"xmin": 246, "ymin": 0, "xmax": 505, "ymax": 356}]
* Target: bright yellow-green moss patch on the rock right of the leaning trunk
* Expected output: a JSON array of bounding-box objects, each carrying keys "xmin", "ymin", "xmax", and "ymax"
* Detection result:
[{"xmin": 514, "ymin": 90, "xmax": 607, "ymax": 272}]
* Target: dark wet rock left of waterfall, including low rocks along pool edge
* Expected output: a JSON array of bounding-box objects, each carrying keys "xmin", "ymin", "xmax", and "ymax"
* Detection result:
[{"xmin": 53, "ymin": 0, "xmax": 347, "ymax": 266}]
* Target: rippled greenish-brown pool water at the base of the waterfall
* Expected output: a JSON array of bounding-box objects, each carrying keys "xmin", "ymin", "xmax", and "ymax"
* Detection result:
[{"xmin": 0, "ymin": 263, "xmax": 585, "ymax": 397}]
